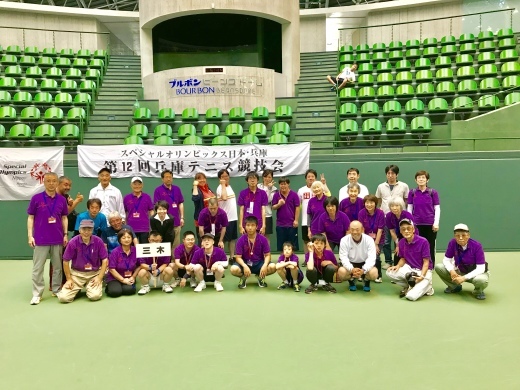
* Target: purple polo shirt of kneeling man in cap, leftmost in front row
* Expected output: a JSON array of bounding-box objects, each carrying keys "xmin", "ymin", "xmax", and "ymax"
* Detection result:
[{"xmin": 63, "ymin": 236, "xmax": 108, "ymax": 272}]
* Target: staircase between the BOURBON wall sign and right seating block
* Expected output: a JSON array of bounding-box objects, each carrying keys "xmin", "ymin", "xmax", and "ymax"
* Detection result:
[{"xmin": 291, "ymin": 51, "xmax": 338, "ymax": 151}]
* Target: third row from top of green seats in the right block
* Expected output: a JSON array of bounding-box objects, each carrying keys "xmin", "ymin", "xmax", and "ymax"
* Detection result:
[{"xmin": 357, "ymin": 49, "xmax": 518, "ymax": 74}]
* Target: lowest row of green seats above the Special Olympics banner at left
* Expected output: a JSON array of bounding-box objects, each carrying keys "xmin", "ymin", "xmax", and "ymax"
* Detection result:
[{"xmin": 0, "ymin": 123, "xmax": 80, "ymax": 141}]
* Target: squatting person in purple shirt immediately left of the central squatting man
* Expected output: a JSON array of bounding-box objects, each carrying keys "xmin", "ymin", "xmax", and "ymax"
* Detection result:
[{"xmin": 186, "ymin": 233, "xmax": 228, "ymax": 292}]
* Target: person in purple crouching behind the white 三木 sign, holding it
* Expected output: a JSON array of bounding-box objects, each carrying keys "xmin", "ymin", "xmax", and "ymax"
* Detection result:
[{"xmin": 137, "ymin": 231, "xmax": 173, "ymax": 295}]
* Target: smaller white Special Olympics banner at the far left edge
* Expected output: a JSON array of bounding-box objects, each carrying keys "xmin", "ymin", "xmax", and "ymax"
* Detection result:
[{"xmin": 0, "ymin": 146, "xmax": 65, "ymax": 200}]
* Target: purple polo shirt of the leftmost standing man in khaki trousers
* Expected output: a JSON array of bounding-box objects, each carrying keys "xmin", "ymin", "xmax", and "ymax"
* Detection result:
[{"xmin": 27, "ymin": 191, "xmax": 69, "ymax": 246}]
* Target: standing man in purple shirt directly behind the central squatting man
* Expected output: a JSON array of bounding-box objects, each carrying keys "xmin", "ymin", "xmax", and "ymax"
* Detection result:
[{"xmin": 237, "ymin": 171, "xmax": 269, "ymax": 235}]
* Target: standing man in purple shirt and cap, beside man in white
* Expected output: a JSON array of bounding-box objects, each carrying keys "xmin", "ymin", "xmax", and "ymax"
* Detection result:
[{"xmin": 123, "ymin": 176, "xmax": 154, "ymax": 244}]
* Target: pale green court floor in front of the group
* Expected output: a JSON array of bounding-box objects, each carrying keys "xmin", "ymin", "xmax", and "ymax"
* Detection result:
[{"xmin": 0, "ymin": 253, "xmax": 520, "ymax": 390}]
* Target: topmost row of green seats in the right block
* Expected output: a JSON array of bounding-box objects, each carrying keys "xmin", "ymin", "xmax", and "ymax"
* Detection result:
[{"xmin": 339, "ymin": 28, "xmax": 514, "ymax": 53}]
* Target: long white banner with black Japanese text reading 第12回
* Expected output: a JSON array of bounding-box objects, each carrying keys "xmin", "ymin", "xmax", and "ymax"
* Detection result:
[{"xmin": 78, "ymin": 142, "xmax": 310, "ymax": 178}]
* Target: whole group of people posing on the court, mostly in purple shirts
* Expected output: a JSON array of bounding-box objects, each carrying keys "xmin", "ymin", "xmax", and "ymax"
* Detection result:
[{"xmin": 27, "ymin": 165, "xmax": 489, "ymax": 305}]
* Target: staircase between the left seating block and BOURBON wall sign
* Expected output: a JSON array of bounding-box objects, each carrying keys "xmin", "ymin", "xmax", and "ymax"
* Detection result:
[{"xmin": 83, "ymin": 55, "xmax": 142, "ymax": 145}]
